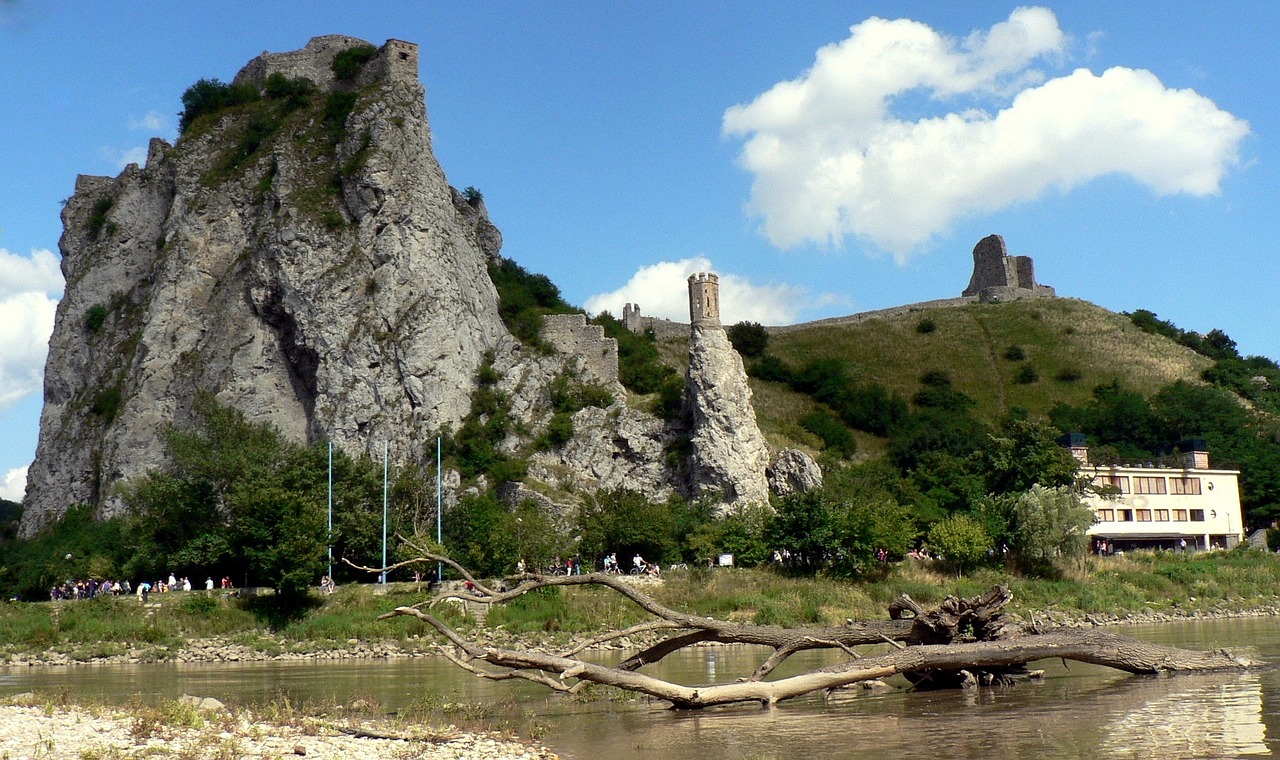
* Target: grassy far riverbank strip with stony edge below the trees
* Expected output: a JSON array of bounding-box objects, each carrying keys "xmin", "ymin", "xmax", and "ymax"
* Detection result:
[{"xmin": 0, "ymin": 550, "xmax": 1280, "ymax": 665}]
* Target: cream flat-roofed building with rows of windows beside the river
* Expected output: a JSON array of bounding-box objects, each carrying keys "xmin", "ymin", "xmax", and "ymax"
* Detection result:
[{"xmin": 1065, "ymin": 434, "xmax": 1244, "ymax": 551}]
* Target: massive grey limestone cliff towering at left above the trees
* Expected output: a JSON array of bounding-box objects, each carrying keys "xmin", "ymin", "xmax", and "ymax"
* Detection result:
[{"xmin": 22, "ymin": 37, "xmax": 507, "ymax": 535}]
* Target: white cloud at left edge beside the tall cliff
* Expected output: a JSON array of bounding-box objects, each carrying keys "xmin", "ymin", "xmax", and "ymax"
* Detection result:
[{"xmin": 0, "ymin": 248, "xmax": 63, "ymax": 408}]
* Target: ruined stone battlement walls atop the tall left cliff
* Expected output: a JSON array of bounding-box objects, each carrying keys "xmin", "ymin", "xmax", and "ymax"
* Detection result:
[{"xmin": 233, "ymin": 35, "xmax": 417, "ymax": 90}]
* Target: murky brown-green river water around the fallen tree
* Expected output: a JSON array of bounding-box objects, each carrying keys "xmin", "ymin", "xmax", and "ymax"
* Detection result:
[{"xmin": 0, "ymin": 618, "xmax": 1280, "ymax": 760}]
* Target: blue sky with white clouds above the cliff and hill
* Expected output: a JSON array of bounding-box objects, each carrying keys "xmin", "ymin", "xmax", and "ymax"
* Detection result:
[{"xmin": 0, "ymin": 0, "xmax": 1280, "ymax": 499}]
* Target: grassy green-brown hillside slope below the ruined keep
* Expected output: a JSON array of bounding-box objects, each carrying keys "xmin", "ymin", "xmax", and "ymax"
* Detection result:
[{"xmin": 662, "ymin": 298, "xmax": 1212, "ymax": 455}]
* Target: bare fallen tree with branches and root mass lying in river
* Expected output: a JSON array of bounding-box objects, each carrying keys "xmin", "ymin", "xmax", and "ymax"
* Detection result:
[{"xmin": 353, "ymin": 550, "xmax": 1258, "ymax": 708}]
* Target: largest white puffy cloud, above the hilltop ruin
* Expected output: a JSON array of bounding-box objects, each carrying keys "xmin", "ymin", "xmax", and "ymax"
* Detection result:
[{"xmin": 723, "ymin": 8, "xmax": 1249, "ymax": 260}]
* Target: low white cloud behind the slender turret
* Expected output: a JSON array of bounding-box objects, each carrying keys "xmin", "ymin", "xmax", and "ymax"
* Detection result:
[{"xmin": 585, "ymin": 256, "xmax": 824, "ymax": 325}]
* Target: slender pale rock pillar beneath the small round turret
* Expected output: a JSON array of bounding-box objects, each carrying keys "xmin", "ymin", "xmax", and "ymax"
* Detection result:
[{"xmin": 685, "ymin": 321, "xmax": 769, "ymax": 509}]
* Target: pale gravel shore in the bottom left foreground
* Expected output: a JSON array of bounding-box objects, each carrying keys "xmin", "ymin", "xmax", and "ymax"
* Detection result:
[{"xmin": 0, "ymin": 693, "xmax": 557, "ymax": 760}]
